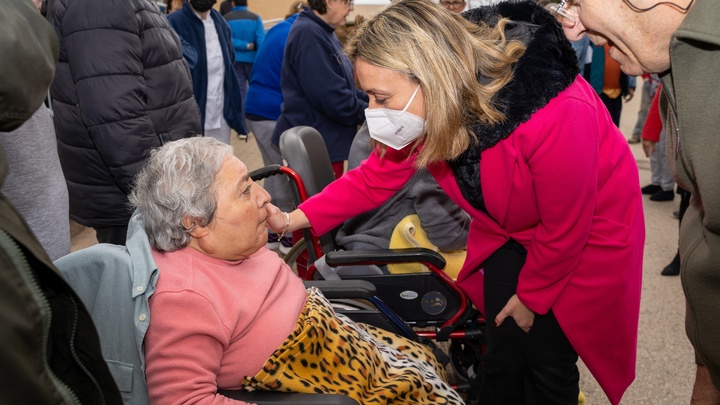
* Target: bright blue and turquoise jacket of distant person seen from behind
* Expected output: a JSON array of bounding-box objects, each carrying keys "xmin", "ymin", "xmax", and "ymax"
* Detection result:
[{"xmin": 225, "ymin": 6, "xmax": 265, "ymax": 63}]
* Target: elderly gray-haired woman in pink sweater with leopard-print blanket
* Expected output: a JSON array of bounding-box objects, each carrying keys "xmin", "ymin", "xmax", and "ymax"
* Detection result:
[{"xmin": 125, "ymin": 138, "xmax": 462, "ymax": 404}]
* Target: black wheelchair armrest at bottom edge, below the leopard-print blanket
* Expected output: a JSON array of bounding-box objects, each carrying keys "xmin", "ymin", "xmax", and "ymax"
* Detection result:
[{"xmin": 218, "ymin": 390, "xmax": 358, "ymax": 405}]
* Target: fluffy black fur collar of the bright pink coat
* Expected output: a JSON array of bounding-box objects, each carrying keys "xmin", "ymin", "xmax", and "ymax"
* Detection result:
[{"xmin": 449, "ymin": 1, "xmax": 579, "ymax": 212}]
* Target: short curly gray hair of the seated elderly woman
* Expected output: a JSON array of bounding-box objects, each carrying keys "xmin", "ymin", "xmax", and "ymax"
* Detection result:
[{"xmin": 129, "ymin": 137, "xmax": 233, "ymax": 252}]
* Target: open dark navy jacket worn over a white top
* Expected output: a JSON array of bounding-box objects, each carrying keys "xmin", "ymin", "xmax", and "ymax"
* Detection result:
[{"xmin": 167, "ymin": 2, "xmax": 247, "ymax": 135}]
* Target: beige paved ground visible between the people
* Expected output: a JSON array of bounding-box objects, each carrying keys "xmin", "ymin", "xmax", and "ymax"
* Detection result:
[{"xmin": 73, "ymin": 92, "xmax": 695, "ymax": 405}]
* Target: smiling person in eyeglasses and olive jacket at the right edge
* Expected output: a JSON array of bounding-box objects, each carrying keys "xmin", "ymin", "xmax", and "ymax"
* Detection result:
[{"xmin": 558, "ymin": 0, "xmax": 720, "ymax": 404}]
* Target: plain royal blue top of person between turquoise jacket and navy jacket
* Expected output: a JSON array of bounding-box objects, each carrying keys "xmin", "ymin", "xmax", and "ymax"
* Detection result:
[{"xmin": 245, "ymin": 14, "xmax": 298, "ymax": 121}]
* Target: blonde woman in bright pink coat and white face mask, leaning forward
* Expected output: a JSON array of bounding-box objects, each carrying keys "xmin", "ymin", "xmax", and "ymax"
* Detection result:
[{"xmin": 268, "ymin": 0, "xmax": 645, "ymax": 405}]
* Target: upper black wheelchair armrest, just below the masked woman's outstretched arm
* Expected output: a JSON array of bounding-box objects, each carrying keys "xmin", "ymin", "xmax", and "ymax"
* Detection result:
[{"xmin": 325, "ymin": 248, "xmax": 445, "ymax": 269}]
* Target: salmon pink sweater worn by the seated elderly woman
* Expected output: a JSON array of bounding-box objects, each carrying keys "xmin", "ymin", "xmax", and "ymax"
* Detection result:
[{"xmin": 145, "ymin": 247, "xmax": 306, "ymax": 405}]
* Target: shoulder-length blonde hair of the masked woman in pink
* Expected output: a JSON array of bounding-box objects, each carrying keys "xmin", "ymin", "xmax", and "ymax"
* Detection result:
[{"xmin": 345, "ymin": 0, "xmax": 525, "ymax": 167}]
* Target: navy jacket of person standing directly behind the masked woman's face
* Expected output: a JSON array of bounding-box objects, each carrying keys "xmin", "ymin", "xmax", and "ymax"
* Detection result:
[{"xmin": 272, "ymin": 9, "xmax": 368, "ymax": 162}]
